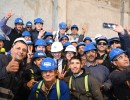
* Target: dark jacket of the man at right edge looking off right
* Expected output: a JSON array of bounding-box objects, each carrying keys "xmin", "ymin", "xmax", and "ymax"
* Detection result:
[{"xmin": 110, "ymin": 66, "xmax": 130, "ymax": 100}]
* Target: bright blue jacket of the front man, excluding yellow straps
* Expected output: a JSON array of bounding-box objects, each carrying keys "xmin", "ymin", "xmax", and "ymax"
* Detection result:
[{"xmin": 28, "ymin": 80, "xmax": 70, "ymax": 100}]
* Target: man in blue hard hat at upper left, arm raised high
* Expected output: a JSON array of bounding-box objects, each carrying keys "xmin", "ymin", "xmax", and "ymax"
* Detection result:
[{"xmin": 0, "ymin": 12, "xmax": 23, "ymax": 51}]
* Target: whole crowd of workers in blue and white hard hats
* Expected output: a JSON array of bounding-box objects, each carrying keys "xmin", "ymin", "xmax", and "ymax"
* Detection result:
[{"xmin": 0, "ymin": 12, "xmax": 130, "ymax": 100}]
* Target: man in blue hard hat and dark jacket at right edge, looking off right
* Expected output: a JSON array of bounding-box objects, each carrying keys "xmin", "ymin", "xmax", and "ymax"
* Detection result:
[{"xmin": 109, "ymin": 48, "xmax": 130, "ymax": 100}]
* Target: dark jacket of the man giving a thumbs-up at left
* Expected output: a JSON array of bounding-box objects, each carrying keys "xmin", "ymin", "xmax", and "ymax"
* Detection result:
[{"xmin": 0, "ymin": 55, "xmax": 24, "ymax": 100}]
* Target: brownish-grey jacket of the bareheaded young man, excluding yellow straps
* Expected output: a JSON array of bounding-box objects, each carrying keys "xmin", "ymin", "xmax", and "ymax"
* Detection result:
[{"xmin": 64, "ymin": 71, "xmax": 103, "ymax": 100}]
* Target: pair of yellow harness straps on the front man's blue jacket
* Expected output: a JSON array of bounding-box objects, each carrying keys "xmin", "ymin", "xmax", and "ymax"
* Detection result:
[{"xmin": 36, "ymin": 79, "xmax": 60, "ymax": 100}]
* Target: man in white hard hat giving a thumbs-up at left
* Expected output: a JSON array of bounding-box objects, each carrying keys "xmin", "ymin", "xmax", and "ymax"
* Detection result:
[{"xmin": 0, "ymin": 38, "xmax": 27, "ymax": 100}]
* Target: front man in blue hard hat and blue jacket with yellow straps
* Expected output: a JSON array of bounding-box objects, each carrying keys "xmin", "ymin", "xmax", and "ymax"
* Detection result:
[{"xmin": 28, "ymin": 57, "xmax": 70, "ymax": 100}]
